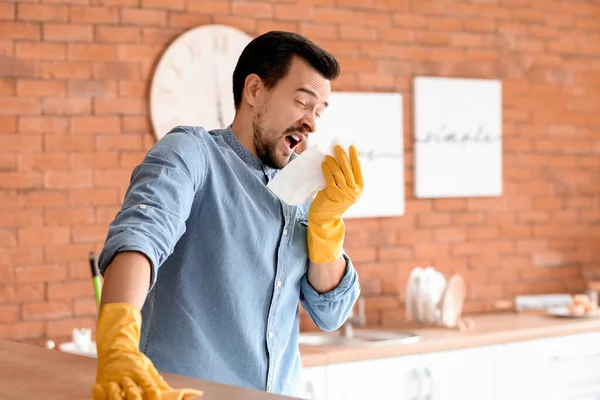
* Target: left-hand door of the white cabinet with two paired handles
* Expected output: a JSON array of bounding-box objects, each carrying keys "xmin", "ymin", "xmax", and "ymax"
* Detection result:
[{"xmin": 326, "ymin": 356, "xmax": 420, "ymax": 400}]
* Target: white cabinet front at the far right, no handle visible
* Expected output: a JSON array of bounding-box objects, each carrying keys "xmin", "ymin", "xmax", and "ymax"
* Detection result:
[{"xmin": 506, "ymin": 332, "xmax": 600, "ymax": 400}]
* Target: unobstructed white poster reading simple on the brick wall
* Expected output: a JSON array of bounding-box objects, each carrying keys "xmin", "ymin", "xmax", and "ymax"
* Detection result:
[{"xmin": 414, "ymin": 77, "xmax": 502, "ymax": 198}]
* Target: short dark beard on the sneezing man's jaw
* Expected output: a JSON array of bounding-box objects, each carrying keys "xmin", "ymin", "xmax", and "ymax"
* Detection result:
[{"xmin": 252, "ymin": 106, "xmax": 297, "ymax": 169}]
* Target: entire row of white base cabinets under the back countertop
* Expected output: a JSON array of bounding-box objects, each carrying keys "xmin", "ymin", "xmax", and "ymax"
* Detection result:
[{"xmin": 300, "ymin": 332, "xmax": 600, "ymax": 400}]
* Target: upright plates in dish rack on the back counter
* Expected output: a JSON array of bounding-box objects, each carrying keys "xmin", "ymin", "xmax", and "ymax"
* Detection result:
[{"xmin": 406, "ymin": 266, "xmax": 474, "ymax": 331}]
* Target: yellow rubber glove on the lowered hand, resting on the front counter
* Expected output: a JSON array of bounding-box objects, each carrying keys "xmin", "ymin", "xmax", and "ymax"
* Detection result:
[{"xmin": 92, "ymin": 303, "xmax": 202, "ymax": 400}]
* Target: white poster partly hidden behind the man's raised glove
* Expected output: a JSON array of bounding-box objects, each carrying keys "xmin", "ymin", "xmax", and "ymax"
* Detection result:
[{"xmin": 307, "ymin": 92, "xmax": 404, "ymax": 218}]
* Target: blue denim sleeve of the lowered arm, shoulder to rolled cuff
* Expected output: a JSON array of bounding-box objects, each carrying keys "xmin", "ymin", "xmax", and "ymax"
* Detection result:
[{"xmin": 98, "ymin": 127, "xmax": 206, "ymax": 288}]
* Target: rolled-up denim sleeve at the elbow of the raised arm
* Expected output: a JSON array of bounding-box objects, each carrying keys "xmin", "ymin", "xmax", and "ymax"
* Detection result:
[{"xmin": 300, "ymin": 253, "xmax": 360, "ymax": 331}]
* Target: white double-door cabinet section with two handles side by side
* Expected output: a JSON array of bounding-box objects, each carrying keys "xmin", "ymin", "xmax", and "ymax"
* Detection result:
[{"xmin": 318, "ymin": 346, "xmax": 504, "ymax": 400}]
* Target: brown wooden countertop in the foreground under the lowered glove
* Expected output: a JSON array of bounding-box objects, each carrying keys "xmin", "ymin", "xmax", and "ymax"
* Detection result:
[{"xmin": 0, "ymin": 340, "xmax": 292, "ymax": 400}]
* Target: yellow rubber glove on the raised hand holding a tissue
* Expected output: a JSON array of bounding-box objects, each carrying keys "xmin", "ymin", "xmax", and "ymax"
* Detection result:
[{"xmin": 307, "ymin": 146, "xmax": 364, "ymax": 264}]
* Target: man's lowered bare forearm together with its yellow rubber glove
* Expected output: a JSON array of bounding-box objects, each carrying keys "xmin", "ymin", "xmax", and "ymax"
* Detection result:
[{"xmin": 92, "ymin": 253, "xmax": 202, "ymax": 400}]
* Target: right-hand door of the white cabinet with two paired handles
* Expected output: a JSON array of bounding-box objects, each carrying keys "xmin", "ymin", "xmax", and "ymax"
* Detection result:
[{"xmin": 420, "ymin": 345, "xmax": 503, "ymax": 400}]
